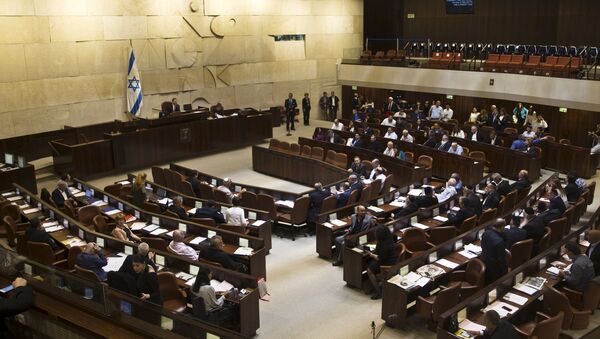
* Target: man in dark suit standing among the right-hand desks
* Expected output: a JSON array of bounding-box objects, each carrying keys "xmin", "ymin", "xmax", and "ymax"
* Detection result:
[{"xmin": 481, "ymin": 218, "xmax": 508, "ymax": 284}]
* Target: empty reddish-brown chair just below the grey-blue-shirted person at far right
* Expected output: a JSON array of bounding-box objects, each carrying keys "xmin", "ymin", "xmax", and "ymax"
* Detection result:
[{"xmin": 544, "ymin": 286, "xmax": 592, "ymax": 330}]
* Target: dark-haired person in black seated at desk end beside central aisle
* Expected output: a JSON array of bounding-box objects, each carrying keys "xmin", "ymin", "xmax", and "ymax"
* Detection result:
[{"xmin": 366, "ymin": 226, "xmax": 398, "ymax": 300}]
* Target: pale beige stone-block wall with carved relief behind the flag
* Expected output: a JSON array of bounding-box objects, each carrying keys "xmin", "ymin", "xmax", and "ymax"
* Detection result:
[{"xmin": 0, "ymin": 0, "xmax": 363, "ymax": 138}]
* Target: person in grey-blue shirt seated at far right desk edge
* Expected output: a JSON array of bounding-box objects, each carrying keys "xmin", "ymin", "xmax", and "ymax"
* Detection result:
[{"xmin": 558, "ymin": 242, "xmax": 595, "ymax": 292}]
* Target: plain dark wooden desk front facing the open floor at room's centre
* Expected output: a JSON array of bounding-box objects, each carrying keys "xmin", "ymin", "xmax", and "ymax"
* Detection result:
[{"xmin": 252, "ymin": 146, "xmax": 348, "ymax": 186}]
